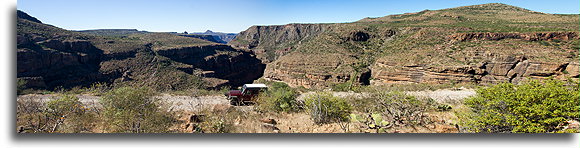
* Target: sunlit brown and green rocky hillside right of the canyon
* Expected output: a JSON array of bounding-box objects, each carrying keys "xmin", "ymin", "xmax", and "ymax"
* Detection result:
[{"xmin": 229, "ymin": 3, "xmax": 580, "ymax": 87}]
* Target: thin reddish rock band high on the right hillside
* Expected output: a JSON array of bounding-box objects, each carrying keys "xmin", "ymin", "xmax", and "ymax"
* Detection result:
[{"xmin": 449, "ymin": 32, "xmax": 580, "ymax": 42}]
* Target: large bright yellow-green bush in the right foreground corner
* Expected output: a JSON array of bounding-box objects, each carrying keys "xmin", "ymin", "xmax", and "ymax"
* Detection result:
[{"xmin": 458, "ymin": 79, "xmax": 580, "ymax": 133}]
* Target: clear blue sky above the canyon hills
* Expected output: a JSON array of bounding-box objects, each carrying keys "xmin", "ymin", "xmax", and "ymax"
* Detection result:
[{"xmin": 17, "ymin": 0, "xmax": 580, "ymax": 33}]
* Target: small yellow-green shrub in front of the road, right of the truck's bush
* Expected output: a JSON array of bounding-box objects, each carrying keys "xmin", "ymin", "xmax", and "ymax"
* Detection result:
[{"xmin": 304, "ymin": 93, "xmax": 352, "ymax": 124}]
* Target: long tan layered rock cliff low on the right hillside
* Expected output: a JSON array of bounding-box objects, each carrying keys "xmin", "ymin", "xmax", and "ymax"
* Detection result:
[{"xmin": 372, "ymin": 56, "xmax": 580, "ymax": 85}]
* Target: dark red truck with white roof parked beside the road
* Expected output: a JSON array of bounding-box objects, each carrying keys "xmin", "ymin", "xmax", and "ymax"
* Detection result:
[{"xmin": 225, "ymin": 84, "xmax": 268, "ymax": 105}]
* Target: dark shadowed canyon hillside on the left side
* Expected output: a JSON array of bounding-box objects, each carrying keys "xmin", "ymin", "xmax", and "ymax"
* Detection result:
[{"xmin": 17, "ymin": 11, "xmax": 264, "ymax": 90}]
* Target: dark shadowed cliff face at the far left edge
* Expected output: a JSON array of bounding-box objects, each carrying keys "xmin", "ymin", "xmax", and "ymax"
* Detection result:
[{"xmin": 17, "ymin": 36, "xmax": 103, "ymax": 88}]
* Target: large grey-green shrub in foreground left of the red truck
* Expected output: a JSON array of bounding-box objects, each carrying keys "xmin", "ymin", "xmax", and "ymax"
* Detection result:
[{"xmin": 101, "ymin": 87, "xmax": 174, "ymax": 133}]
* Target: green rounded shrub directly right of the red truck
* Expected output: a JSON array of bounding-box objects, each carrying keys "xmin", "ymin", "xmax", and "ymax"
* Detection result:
[{"xmin": 256, "ymin": 82, "xmax": 298, "ymax": 112}]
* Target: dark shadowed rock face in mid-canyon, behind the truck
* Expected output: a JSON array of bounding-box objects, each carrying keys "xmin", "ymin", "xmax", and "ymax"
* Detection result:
[{"xmin": 157, "ymin": 45, "xmax": 266, "ymax": 86}]
